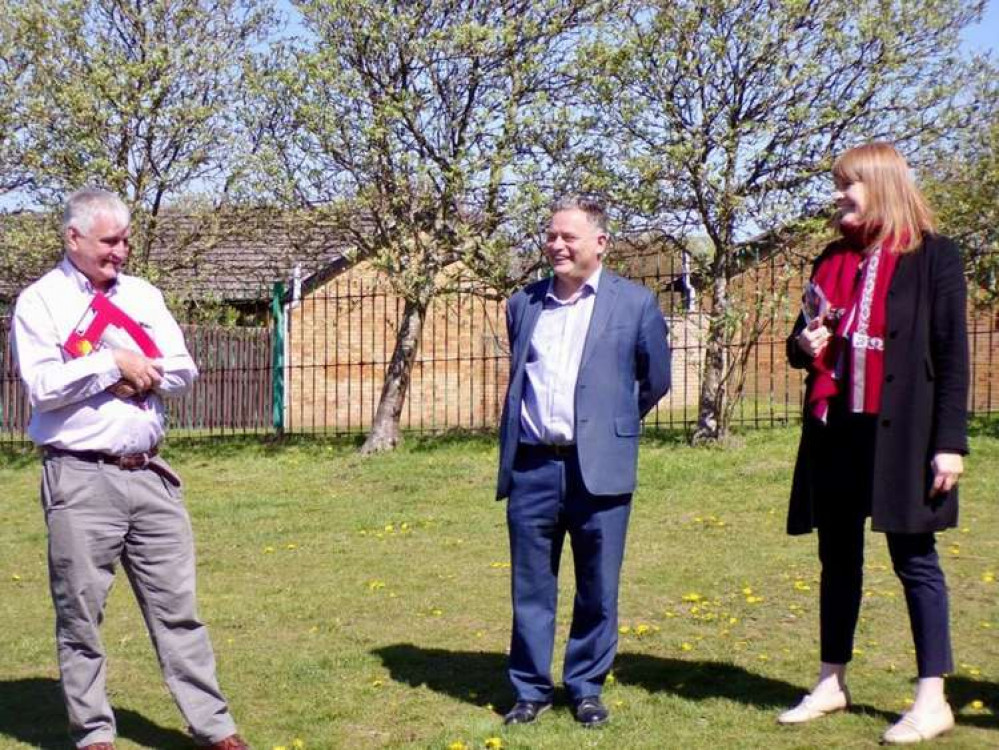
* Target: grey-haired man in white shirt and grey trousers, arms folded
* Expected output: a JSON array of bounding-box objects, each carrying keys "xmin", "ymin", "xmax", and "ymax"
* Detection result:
[{"xmin": 14, "ymin": 188, "xmax": 247, "ymax": 750}]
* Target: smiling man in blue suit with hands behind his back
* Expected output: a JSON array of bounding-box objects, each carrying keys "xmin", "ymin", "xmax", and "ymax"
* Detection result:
[{"xmin": 496, "ymin": 196, "xmax": 670, "ymax": 727}]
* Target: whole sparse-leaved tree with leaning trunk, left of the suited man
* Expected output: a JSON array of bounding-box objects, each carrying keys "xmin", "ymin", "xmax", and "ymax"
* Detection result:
[{"xmin": 254, "ymin": 0, "xmax": 602, "ymax": 452}]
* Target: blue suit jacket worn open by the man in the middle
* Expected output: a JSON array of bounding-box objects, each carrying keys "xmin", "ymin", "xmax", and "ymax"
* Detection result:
[{"xmin": 496, "ymin": 268, "xmax": 670, "ymax": 499}]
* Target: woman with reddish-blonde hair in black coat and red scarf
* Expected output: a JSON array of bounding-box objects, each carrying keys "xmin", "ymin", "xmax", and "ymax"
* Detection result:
[{"xmin": 778, "ymin": 143, "xmax": 968, "ymax": 744}]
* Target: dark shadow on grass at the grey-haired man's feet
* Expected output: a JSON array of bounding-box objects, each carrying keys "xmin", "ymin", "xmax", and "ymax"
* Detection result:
[{"xmin": 0, "ymin": 677, "xmax": 193, "ymax": 750}]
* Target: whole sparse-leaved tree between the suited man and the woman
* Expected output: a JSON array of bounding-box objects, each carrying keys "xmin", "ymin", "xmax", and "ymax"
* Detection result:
[{"xmin": 581, "ymin": 0, "xmax": 982, "ymax": 440}]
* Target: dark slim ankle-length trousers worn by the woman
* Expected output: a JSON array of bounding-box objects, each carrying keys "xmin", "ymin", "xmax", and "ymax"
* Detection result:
[{"xmin": 816, "ymin": 410, "xmax": 954, "ymax": 677}]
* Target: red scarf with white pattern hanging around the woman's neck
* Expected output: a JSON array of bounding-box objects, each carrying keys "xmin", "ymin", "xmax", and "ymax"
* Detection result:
[{"xmin": 807, "ymin": 233, "xmax": 898, "ymax": 422}]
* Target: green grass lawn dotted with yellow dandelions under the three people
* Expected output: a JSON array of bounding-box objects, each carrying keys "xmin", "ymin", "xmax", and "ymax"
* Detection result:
[{"xmin": 0, "ymin": 429, "xmax": 999, "ymax": 750}]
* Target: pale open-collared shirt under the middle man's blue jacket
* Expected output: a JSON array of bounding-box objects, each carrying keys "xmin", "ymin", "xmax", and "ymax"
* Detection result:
[{"xmin": 520, "ymin": 267, "xmax": 603, "ymax": 445}]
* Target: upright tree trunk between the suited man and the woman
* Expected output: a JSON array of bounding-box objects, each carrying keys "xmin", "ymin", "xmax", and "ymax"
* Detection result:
[{"xmin": 692, "ymin": 274, "xmax": 731, "ymax": 443}]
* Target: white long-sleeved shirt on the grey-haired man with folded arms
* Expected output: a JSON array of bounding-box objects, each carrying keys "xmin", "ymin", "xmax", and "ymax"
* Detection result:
[{"xmin": 14, "ymin": 258, "xmax": 198, "ymax": 455}]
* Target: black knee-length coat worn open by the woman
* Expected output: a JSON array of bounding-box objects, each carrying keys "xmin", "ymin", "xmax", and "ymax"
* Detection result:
[{"xmin": 787, "ymin": 235, "xmax": 968, "ymax": 534}]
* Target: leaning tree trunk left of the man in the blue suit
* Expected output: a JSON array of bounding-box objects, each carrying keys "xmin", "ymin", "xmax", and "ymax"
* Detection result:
[{"xmin": 361, "ymin": 299, "xmax": 430, "ymax": 454}]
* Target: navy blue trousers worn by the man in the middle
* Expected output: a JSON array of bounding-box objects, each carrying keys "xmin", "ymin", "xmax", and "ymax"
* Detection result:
[{"xmin": 507, "ymin": 449, "xmax": 631, "ymax": 702}]
